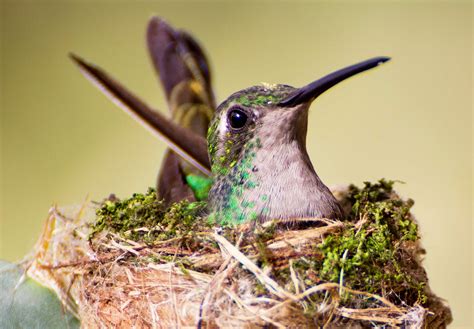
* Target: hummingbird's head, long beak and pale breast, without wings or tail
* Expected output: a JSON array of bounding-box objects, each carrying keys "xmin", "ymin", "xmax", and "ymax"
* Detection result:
[{"xmin": 207, "ymin": 57, "xmax": 388, "ymax": 224}]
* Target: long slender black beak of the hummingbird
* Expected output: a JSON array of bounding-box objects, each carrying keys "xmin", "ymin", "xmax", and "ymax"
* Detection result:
[{"xmin": 279, "ymin": 57, "xmax": 390, "ymax": 107}]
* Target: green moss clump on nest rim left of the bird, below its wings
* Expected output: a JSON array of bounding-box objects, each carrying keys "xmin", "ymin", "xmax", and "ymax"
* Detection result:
[{"xmin": 90, "ymin": 188, "xmax": 207, "ymax": 244}]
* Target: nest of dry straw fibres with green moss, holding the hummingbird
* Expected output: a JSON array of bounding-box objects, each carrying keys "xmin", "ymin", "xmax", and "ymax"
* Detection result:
[{"xmin": 23, "ymin": 180, "xmax": 452, "ymax": 328}]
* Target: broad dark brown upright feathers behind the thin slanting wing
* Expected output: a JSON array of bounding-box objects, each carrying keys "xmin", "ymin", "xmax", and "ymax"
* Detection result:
[{"xmin": 146, "ymin": 17, "xmax": 215, "ymax": 203}]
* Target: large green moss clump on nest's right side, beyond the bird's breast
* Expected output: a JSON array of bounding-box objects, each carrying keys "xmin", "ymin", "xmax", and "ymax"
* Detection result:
[{"xmin": 308, "ymin": 179, "xmax": 426, "ymax": 305}]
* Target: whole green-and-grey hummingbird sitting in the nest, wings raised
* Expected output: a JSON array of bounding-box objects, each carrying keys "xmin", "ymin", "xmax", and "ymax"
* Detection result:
[{"xmin": 71, "ymin": 17, "xmax": 390, "ymax": 226}]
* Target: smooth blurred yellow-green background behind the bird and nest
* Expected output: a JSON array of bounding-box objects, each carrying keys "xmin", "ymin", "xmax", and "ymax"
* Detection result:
[{"xmin": 0, "ymin": 1, "xmax": 473, "ymax": 328}]
